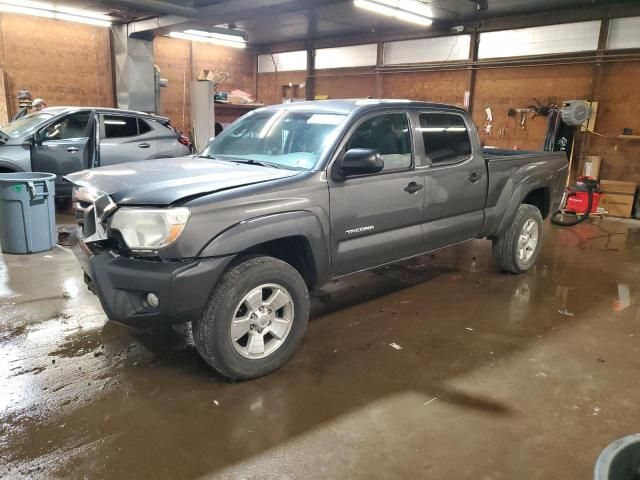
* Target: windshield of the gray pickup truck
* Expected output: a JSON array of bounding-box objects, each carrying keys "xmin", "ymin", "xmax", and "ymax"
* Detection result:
[{"xmin": 202, "ymin": 110, "xmax": 346, "ymax": 170}]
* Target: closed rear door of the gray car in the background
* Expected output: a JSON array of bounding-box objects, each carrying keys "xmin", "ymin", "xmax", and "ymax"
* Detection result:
[{"xmin": 100, "ymin": 113, "xmax": 158, "ymax": 166}]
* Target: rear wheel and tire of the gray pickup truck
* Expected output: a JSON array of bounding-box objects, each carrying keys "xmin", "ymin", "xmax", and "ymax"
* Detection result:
[{"xmin": 493, "ymin": 204, "xmax": 542, "ymax": 273}]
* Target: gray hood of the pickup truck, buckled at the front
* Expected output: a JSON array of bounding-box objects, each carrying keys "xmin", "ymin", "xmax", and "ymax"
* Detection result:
[{"xmin": 65, "ymin": 156, "xmax": 300, "ymax": 205}]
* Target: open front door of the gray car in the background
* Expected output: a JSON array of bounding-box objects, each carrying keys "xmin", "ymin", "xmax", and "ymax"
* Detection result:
[{"xmin": 31, "ymin": 110, "xmax": 96, "ymax": 177}]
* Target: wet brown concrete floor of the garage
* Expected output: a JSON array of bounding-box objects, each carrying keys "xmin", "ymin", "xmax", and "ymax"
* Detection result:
[{"xmin": 0, "ymin": 216, "xmax": 640, "ymax": 480}]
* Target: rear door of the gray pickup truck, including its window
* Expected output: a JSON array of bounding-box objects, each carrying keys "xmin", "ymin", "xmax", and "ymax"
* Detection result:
[{"xmin": 413, "ymin": 110, "xmax": 487, "ymax": 251}]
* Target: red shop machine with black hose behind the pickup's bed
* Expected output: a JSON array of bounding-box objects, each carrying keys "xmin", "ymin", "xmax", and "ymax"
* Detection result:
[{"xmin": 551, "ymin": 177, "xmax": 602, "ymax": 227}]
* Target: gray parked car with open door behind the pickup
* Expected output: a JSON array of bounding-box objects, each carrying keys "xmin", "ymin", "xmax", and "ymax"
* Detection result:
[{"xmin": 0, "ymin": 107, "xmax": 191, "ymax": 196}]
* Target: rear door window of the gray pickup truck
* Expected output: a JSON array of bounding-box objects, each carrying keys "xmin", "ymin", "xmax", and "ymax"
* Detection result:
[{"xmin": 420, "ymin": 113, "xmax": 471, "ymax": 165}]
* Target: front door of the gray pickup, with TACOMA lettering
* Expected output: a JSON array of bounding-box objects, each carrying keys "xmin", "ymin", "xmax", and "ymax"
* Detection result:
[{"xmin": 329, "ymin": 112, "xmax": 424, "ymax": 276}]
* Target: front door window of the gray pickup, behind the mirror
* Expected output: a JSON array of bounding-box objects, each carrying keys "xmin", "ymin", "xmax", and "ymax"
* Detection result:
[{"xmin": 346, "ymin": 113, "xmax": 411, "ymax": 172}]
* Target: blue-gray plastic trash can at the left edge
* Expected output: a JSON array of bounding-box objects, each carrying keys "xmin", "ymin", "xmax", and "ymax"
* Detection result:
[{"xmin": 0, "ymin": 172, "xmax": 56, "ymax": 253}]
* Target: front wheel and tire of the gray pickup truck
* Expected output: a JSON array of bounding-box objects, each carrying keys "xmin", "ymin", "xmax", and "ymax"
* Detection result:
[{"xmin": 193, "ymin": 256, "xmax": 309, "ymax": 381}]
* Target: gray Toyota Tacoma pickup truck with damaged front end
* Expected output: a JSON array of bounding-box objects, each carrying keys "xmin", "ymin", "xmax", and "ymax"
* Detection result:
[{"xmin": 67, "ymin": 100, "xmax": 568, "ymax": 380}]
